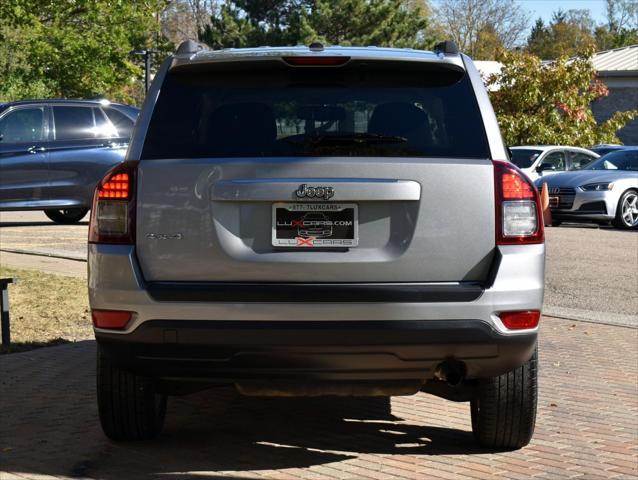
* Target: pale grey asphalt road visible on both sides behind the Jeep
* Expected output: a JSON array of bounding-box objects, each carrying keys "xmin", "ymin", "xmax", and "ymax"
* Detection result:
[{"xmin": 0, "ymin": 212, "xmax": 638, "ymax": 326}]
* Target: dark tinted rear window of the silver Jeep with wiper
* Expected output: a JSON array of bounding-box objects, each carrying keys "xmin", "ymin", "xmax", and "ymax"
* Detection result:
[{"xmin": 142, "ymin": 63, "xmax": 489, "ymax": 159}]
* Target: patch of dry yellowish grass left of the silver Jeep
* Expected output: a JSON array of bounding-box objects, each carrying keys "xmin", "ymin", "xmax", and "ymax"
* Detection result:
[{"xmin": 0, "ymin": 266, "xmax": 93, "ymax": 353}]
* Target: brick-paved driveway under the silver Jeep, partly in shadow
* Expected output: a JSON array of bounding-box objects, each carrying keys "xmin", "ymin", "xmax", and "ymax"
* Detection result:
[{"xmin": 0, "ymin": 318, "xmax": 638, "ymax": 480}]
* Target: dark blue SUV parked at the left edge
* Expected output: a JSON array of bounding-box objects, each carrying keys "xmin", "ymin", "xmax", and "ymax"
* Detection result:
[{"xmin": 0, "ymin": 100, "xmax": 139, "ymax": 223}]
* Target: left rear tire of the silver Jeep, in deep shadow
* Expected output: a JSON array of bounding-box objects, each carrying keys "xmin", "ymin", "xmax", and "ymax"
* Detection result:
[{"xmin": 97, "ymin": 347, "xmax": 166, "ymax": 441}]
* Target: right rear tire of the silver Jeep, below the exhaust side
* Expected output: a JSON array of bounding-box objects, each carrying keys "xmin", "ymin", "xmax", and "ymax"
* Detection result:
[{"xmin": 470, "ymin": 347, "xmax": 538, "ymax": 450}]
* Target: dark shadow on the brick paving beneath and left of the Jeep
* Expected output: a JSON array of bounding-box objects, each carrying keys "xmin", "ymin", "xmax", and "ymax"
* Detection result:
[{"xmin": 0, "ymin": 342, "xmax": 490, "ymax": 480}]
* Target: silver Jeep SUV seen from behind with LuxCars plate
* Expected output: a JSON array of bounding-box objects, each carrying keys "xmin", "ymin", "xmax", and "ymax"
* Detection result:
[{"xmin": 88, "ymin": 42, "xmax": 545, "ymax": 448}]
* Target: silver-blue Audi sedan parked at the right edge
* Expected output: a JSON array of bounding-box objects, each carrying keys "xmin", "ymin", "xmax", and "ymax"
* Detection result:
[{"xmin": 536, "ymin": 147, "xmax": 638, "ymax": 228}]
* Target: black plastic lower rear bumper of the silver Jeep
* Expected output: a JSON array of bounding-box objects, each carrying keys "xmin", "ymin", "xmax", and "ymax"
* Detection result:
[{"xmin": 96, "ymin": 320, "xmax": 537, "ymax": 384}]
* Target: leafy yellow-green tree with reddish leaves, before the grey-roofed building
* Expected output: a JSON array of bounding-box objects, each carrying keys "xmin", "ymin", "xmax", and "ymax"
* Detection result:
[{"xmin": 487, "ymin": 47, "xmax": 638, "ymax": 147}]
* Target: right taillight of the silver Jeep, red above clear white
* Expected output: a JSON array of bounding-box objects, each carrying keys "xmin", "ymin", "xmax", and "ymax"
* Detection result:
[{"xmin": 492, "ymin": 160, "xmax": 545, "ymax": 245}]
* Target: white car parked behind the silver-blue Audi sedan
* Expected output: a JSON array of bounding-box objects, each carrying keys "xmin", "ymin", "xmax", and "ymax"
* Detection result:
[{"xmin": 510, "ymin": 145, "xmax": 599, "ymax": 180}]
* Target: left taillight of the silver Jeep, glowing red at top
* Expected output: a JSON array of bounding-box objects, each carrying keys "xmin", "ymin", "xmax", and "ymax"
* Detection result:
[{"xmin": 89, "ymin": 162, "xmax": 137, "ymax": 244}]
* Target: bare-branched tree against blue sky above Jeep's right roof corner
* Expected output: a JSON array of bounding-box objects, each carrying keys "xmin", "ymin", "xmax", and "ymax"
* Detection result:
[{"xmin": 436, "ymin": 0, "xmax": 529, "ymax": 59}]
